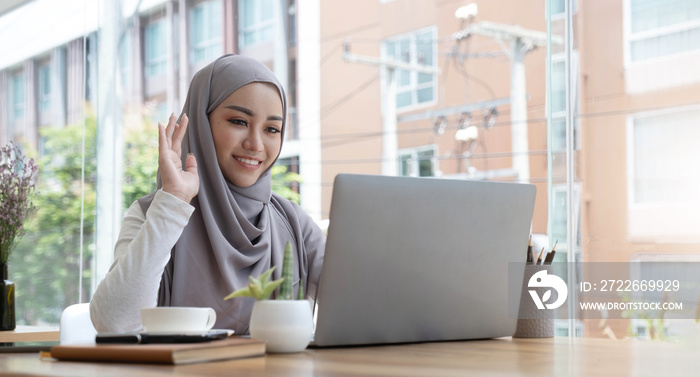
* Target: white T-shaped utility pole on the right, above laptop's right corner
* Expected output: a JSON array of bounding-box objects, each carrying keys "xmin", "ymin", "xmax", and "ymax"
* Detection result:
[{"xmin": 452, "ymin": 21, "xmax": 561, "ymax": 182}]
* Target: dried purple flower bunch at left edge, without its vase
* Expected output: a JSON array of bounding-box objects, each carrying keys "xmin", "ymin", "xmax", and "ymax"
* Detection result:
[{"xmin": 0, "ymin": 142, "xmax": 39, "ymax": 263}]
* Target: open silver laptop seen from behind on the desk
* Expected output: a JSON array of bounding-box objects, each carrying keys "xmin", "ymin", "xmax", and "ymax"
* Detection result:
[{"xmin": 313, "ymin": 174, "xmax": 535, "ymax": 346}]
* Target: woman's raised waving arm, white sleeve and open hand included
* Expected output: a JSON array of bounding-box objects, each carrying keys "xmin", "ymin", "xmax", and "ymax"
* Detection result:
[{"xmin": 90, "ymin": 114, "xmax": 199, "ymax": 332}]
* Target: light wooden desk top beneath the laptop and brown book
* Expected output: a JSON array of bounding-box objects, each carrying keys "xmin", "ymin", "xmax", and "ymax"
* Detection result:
[{"xmin": 0, "ymin": 338, "xmax": 700, "ymax": 377}]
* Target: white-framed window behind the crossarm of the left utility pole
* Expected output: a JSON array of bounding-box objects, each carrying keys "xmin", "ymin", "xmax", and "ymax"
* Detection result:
[{"xmin": 384, "ymin": 27, "xmax": 437, "ymax": 110}]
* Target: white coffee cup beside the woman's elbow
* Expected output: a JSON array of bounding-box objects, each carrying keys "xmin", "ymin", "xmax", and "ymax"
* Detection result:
[{"xmin": 141, "ymin": 306, "xmax": 216, "ymax": 333}]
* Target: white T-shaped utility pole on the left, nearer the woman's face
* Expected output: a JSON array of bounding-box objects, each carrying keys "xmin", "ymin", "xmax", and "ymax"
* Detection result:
[{"xmin": 343, "ymin": 41, "xmax": 440, "ymax": 175}]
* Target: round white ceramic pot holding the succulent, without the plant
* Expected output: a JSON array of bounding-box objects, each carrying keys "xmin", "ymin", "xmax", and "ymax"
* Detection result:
[{"xmin": 250, "ymin": 300, "xmax": 313, "ymax": 353}]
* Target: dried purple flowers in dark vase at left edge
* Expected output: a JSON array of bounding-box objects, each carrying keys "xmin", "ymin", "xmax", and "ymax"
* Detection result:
[{"xmin": 0, "ymin": 142, "xmax": 39, "ymax": 331}]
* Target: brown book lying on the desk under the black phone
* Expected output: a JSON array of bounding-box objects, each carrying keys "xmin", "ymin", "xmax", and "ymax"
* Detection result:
[{"xmin": 51, "ymin": 337, "xmax": 265, "ymax": 365}]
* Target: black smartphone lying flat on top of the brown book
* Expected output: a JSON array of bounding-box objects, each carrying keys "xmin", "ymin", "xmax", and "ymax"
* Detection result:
[{"xmin": 95, "ymin": 330, "xmax": 233, "ymax": 344}]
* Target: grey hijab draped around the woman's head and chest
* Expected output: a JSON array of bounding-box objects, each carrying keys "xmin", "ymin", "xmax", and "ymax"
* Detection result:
[{"xmin": 139, "ymin": 55, "xmax": 310, "ymax": 333}]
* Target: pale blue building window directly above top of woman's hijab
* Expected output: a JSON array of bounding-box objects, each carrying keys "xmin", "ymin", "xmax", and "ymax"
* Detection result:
[{"xmin": 190, "ymin": 0, "xmax": 222, "ymax": 63}]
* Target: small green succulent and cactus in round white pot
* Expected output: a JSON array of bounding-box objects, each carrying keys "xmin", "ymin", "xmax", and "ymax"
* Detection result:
[{"xmin": 224, "ymin": 242, "xmax": 313, "ymax": 353}]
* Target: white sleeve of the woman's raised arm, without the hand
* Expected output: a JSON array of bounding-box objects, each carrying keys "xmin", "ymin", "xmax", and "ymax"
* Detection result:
[{"xmin": 90, "ymin": 190, "xmax": 194, "ymax": 332}]
